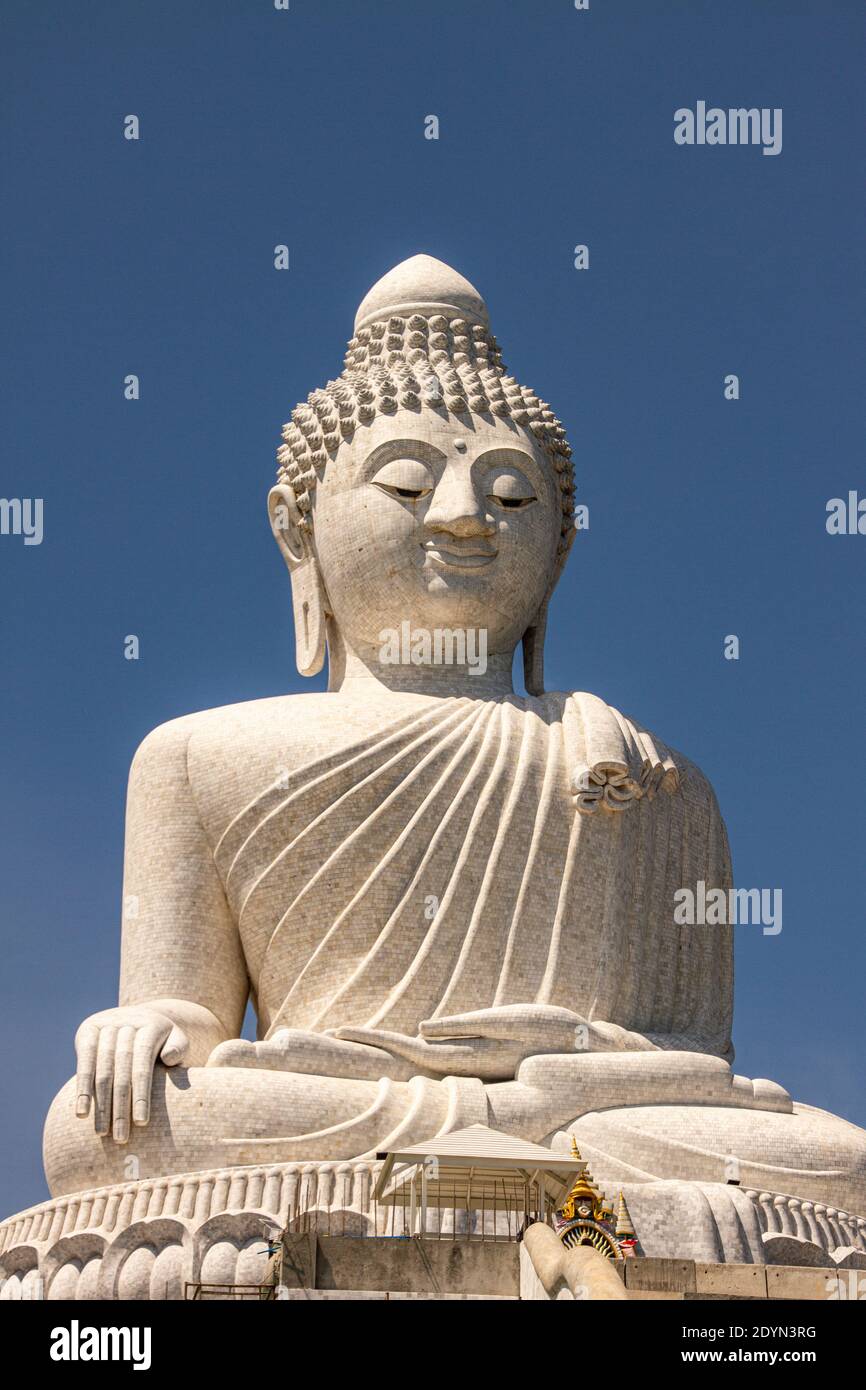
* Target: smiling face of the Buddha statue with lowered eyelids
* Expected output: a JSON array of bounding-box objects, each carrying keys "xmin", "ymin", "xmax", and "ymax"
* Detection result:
[{"xmin": 313, "ymin": 409, "xmax": 562, "ymax": 653}]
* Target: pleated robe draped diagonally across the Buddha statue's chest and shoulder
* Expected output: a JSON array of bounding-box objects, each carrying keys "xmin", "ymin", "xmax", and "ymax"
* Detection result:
[{"xmin": 214, "ymin": 695, "xmax": 733, "ymax": 1056}]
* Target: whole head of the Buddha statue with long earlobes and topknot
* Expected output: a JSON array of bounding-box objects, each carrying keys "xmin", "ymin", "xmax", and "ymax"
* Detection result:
[{"xmin": 268, "ymin": 256, "xmax": 574, "ymax": 694}]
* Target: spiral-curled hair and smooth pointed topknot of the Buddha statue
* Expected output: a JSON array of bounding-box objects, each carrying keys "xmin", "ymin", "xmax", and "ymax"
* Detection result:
[{"xmin": 277, "ymin": 256, "xmax": 574, "ymax": 564}]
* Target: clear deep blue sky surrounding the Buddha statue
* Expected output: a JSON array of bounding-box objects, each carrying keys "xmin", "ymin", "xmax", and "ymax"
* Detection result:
[{"xmin": 0, "ymin": 0, "xmax": 866, "ymax": 1215}]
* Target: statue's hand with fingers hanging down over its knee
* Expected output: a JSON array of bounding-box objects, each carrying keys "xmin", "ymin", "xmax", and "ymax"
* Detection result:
[{"xmin": 75, "ymin": 999, "xmax": 225, "ymax": 1144}]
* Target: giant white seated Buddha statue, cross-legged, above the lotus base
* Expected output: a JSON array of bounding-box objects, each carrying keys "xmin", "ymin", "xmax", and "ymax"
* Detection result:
[{"xmin": 44, "ymin": 256, "xmax": 866, "ymax": 1211}]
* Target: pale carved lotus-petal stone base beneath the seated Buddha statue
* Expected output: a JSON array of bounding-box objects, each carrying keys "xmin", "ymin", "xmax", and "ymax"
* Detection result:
[{"xmin": 0, "ymin": 1161, "xmax": 866, "ymax": 1300}]
